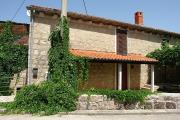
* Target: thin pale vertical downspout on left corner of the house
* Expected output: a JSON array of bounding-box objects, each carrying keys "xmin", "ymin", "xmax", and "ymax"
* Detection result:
[{"xmin": 27, "ymin": 11, "xmax": 34, "ymax": 85}]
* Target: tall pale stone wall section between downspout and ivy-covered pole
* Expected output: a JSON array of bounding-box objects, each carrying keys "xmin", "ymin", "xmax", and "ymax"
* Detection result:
[{"xmin": 31, "ymin": 17, "xmax": 56, "ymax": 84}]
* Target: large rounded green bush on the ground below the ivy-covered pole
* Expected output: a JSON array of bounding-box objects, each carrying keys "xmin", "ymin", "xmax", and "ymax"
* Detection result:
[{"xmin": 6, "ymin": 81, "xmax": 77, "ymax": 115}]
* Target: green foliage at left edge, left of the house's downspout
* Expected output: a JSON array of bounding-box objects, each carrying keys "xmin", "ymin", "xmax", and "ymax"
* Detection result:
[{"xmin": 0, "ymin": 22, "xmax": 28, "ymax": 95}]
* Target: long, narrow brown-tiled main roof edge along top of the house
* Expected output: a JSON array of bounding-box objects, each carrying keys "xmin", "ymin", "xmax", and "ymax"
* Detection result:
[{"xmin": 27, "ymin": 5, "xmax": 180, "ymax": 38}]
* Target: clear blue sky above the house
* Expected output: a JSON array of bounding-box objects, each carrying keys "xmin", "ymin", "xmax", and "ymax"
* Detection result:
[{"xmin": 0, "ymin": 0, "xmax": 180, "ymax": 32}]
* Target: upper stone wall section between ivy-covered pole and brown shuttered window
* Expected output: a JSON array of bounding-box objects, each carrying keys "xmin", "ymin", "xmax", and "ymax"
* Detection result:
[{"xmin": 70, "ymin": 20, "xmax": 116, "ymax": 52}]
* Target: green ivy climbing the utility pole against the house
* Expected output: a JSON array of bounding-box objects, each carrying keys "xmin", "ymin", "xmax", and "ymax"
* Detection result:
[{"xmin": 49, "ymin": 17, "xmax": 88, "ymax": 89}]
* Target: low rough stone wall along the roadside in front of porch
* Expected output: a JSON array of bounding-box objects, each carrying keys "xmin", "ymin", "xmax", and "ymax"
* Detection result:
[{"xmin": 77, "ymin": 94, "xmax": 180, "ymax": 110}]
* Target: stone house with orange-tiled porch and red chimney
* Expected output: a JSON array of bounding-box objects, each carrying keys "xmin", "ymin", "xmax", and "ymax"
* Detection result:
[{"xmin": 27, "ymin": 6, "xmax": 180, "ymax": 91}]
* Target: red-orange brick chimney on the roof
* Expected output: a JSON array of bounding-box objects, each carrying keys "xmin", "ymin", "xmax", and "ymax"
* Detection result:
[{"xmin": 135, "ymin": 11, "xmax": 144, "ymax": 25}]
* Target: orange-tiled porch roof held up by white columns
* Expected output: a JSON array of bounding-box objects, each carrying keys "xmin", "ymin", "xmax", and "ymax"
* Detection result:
[{"xmin": 70, "ymin": 49, "xmax": 158, "ymax": 63}]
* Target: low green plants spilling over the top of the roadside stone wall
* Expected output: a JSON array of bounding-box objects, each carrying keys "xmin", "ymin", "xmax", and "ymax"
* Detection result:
[{"xmin": 82, "ymin": 89, "xmax": 152, "ymax": 104}]
